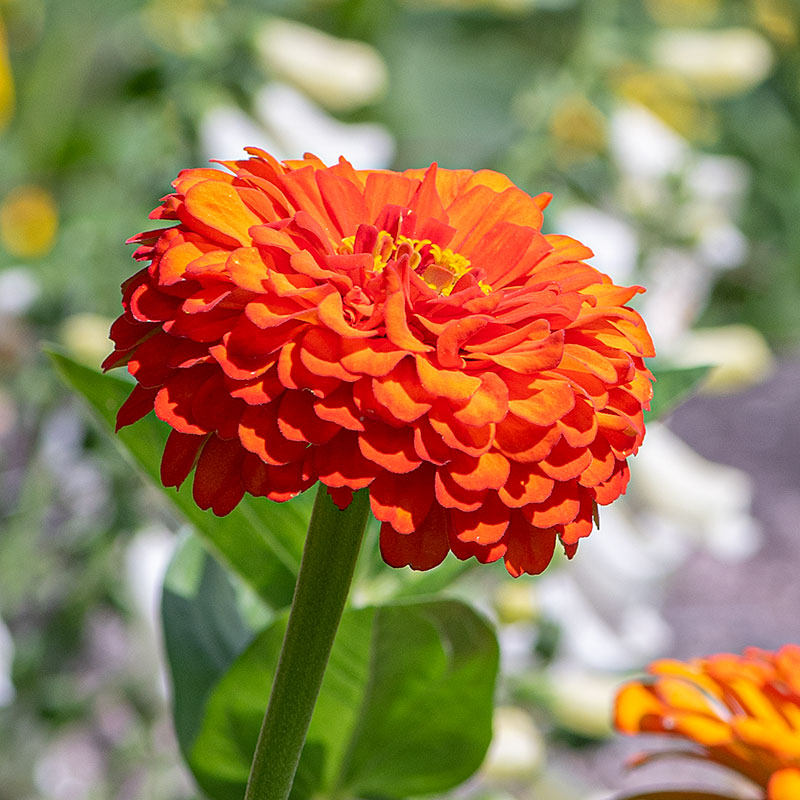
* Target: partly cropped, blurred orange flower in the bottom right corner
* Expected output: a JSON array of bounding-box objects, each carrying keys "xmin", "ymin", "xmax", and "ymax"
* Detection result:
[{"xmin": 615, "ymin": 645, "xmax": 800, "ymax": 800}]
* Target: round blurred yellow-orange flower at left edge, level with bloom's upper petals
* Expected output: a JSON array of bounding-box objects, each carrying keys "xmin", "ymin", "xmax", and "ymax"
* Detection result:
[{"xmin": 0, "ymin": 186, "xmax": 58, "ymax": 258}]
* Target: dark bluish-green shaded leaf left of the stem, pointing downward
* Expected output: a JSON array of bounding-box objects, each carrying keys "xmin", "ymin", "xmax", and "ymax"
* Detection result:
[{"xmin": 161, "ymin": 535, "xmax": 253, "ymax": 755}]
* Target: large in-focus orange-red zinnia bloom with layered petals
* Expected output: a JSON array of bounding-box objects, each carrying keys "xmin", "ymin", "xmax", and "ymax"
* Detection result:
[{"xmin": 104, "ymin": 149, "xmax": 653, "ymax": 575}]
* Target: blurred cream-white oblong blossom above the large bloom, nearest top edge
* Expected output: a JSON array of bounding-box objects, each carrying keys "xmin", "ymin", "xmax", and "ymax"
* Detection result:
[{"xmin": 256, "ymin": 19, "xmax": 389, "ymax": 111}]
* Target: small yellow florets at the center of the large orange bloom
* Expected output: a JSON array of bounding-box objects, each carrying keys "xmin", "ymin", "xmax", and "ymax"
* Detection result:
[{"xmin": 339, "ymin": 231, "xmax": 491, "ymax": 297}]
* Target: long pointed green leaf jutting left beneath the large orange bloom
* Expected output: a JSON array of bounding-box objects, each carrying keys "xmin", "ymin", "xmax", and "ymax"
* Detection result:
[{"xmin": 48, "ymin": 350, "xmax": 310, "ymax": 609}]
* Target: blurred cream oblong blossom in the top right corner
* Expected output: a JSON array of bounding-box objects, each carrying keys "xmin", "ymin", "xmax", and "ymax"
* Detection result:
[{"xmin": 653, "ymin": 28, "xmax": 774, "ymax": 96}]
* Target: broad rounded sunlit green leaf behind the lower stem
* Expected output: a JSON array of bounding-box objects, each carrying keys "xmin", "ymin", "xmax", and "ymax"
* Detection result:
[{"xmin": 189, "ymin": 600, "xmax": 498, "ymax": 800}]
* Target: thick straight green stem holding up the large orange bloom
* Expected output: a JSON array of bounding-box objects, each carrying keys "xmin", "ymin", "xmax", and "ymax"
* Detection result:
[{"xmin": 245, "ymin": 484, "xmax": 369, "ymax": 800}]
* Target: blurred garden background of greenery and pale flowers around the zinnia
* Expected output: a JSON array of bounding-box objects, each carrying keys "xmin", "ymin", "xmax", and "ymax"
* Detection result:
[{"xmin": 0, "ymin": 0, "xmax": 800, "ymax": 800}]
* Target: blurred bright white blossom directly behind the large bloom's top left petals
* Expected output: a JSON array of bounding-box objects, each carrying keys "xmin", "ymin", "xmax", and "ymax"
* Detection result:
[{"xmin": 200, "ymin": 83, "xmax": 395, "ymax": 169}]
